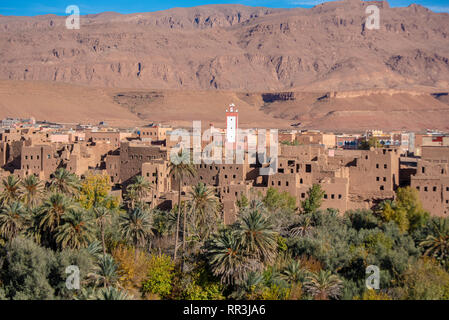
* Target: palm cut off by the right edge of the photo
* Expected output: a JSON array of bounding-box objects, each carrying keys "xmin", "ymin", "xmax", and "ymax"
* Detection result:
[{"xmin": 420, "ymin": 218, "xmax": 449, "ymax": 263}]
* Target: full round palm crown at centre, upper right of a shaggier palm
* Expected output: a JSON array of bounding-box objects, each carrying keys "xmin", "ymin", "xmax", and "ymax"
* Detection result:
[{"xmin": 236, "ymin": 210, "xmax": 277, "ymax": 263}]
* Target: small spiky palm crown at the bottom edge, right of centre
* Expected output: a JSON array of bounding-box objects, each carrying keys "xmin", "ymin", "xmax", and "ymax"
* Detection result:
[{"xmin": 304, "ymin": 270, "xmax": 343, "ymax": 300}]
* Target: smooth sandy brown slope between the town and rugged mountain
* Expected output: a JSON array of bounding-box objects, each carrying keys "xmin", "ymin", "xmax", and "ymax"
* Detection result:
[{"xmin": 0, "ymin": 80, "xmax": 449, "ymax": 131}]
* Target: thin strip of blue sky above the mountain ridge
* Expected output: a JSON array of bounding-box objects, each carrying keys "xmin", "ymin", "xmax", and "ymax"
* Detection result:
[{"xmin": 0, "ymin": 0, "xmax": 449, "ymax": 16}]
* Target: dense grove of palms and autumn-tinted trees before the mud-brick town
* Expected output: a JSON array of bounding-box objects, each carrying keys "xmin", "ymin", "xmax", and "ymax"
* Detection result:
[{"xmin": 0, "ymin": 162, "xmax": 449, "ymax": 300}]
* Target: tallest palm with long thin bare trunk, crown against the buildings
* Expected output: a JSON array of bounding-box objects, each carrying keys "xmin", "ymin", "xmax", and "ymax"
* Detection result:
[{"xmin": 170, "ymin": 150, "xmax": 196, "ymax": 261}]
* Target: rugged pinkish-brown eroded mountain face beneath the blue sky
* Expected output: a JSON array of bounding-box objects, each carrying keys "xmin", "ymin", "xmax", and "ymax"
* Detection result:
[{"xmin": 0, "ymin": 1, "xmax": 449, "ymax": 94}]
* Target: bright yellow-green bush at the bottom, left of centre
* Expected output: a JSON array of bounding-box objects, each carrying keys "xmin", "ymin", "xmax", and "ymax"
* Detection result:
[{"xmin": 142, "ymin": 254, "xmax": 175, "ymax": 298}]
